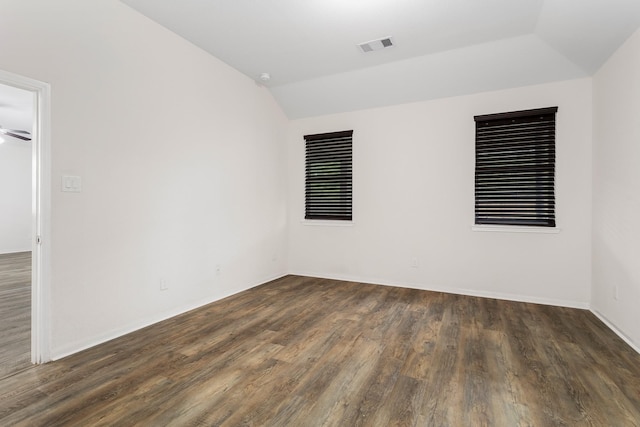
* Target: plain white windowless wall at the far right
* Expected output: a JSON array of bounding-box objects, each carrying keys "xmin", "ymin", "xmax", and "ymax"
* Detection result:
[{"xmin": 592, "ymin": 31, "xmax": 640, "ymax": 348}]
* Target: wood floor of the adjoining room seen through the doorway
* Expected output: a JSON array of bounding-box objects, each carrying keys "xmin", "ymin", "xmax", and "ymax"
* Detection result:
[{"xmin": 0, "ymin": 252, "xmax": 31, "ymax": 378}]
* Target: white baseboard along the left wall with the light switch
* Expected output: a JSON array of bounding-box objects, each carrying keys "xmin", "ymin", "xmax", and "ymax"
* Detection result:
[{"xmin": 52, "ymin": 274, "xmax": 287, "ymax": 360}]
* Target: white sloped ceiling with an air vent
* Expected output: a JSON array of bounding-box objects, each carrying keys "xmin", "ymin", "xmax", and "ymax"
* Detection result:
[{"xmin": 122, "ymin": 0, "xmax": 640, "ymax": 118}]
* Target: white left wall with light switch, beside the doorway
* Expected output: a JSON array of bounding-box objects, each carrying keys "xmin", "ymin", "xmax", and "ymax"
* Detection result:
[{"xmin": 0, "ymin": 0, "xmax": 287, "ymax": 356}]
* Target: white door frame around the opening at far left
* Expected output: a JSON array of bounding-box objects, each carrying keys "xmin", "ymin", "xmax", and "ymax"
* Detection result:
[{"xmin": 0, "ymin": 70, "xmax": 51, "ymax": 364}]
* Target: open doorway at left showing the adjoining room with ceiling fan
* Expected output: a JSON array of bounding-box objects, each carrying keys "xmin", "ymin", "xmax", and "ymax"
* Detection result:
[{"xmin": 0, "ymin": 84, "xmax": 34, "ymax": 378}]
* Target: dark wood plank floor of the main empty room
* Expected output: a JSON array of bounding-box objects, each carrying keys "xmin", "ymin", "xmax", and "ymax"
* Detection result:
[{"xmin": 0, "ymin": 276, "xmax": 640, "ymax": 426}]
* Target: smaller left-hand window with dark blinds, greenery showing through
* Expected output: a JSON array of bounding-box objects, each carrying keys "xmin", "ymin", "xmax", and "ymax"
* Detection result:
[{"xmin": 304, "ymin": 130, "xmax": 353, "ymax": 221}]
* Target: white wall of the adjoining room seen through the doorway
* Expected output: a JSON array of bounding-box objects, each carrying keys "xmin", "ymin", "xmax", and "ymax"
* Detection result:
[{"xmin": 0, "ymin": 140, "xmax": 31, "ymax": 254}]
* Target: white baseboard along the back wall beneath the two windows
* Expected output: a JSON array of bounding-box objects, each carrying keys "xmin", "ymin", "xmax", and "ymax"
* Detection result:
[{"xmin": 289, "ymin": 271, "xmax": 589, "ymax": 310}]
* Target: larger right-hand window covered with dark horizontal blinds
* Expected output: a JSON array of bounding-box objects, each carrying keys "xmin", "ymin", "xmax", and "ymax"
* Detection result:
[{"xmin": 474, "ymin": 107, "xmax": 558, "ymax": 227}]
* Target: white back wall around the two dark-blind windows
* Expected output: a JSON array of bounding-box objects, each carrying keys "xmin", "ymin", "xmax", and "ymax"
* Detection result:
[{"xmin": 288, "ymin": 79, "xmax": 592, "ymax": 307}]
